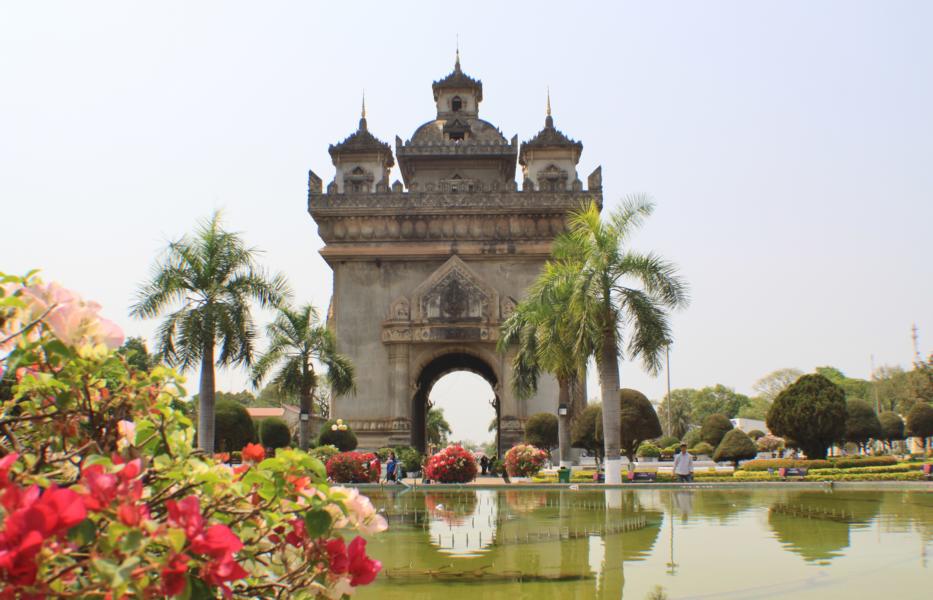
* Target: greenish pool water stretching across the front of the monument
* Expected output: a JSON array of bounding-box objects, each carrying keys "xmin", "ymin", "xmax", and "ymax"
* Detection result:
[{"xmin": 355, "ymin": 484, "xmax": 933, "ymax": 600}]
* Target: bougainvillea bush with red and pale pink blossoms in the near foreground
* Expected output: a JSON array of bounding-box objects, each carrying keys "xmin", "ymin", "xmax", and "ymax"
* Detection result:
[{"xmin": 0, "ymin": 274, "xmax": 386, "ymax": 599}]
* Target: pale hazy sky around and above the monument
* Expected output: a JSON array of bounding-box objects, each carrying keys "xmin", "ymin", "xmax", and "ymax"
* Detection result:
[{"xmin": 0, "ymin": 0, "xmax": 933, "ymax": 440}]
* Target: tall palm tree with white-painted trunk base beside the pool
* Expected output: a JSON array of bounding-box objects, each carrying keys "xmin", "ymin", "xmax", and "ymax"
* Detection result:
[{"xmin": 551, "ymin": 196, "xmax": 687, "ymax": 483}]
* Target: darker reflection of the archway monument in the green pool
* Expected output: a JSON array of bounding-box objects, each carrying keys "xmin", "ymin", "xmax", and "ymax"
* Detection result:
[{"xmin": 371, "ymin": 489, "xmax": 663, "ymax": 600}]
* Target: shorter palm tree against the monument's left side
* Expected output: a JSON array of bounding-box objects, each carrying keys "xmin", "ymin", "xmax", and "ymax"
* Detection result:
[{"xmin": 252, "ymin": 304, "xmax": 356, "ymax": 450}]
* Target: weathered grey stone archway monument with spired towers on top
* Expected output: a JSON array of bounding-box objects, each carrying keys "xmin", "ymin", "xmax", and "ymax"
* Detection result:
[{"xmin": 308, "ymin": 57, "xmax": 602, "ymax": 448}]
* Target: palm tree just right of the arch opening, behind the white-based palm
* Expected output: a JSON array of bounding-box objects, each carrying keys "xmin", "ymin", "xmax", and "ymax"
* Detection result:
[{"xmin": 498, "ymin": 263, "xmax": 588, "ymax": 464}]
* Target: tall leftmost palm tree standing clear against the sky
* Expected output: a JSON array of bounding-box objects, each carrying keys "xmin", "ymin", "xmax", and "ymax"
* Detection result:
[{"xmin": 130, "ymin": 213, "xmax": 288, "ymax": 452}]
